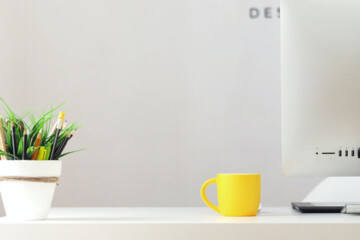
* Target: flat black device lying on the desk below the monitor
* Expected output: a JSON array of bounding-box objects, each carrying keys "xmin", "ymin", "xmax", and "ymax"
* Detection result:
[{"xmin": 291, "ymin": 202, "xmax": 345, "ymax": 213}]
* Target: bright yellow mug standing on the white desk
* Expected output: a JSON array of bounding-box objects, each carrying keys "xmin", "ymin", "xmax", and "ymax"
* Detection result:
[{"xmin": 201, "ymin": 174, "xmax": 261, "ymax": 216}]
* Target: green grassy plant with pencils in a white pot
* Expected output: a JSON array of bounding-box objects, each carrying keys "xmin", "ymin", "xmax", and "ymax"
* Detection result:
[{"xmin": 0, "ymin": 98, "xmax": 79, "ymax": 220}]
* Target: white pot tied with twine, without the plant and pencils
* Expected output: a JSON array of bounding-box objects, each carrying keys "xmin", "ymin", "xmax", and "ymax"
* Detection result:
[{"xmin": 0, "ymin": 160, "xmax": 61, "ymax": 220}]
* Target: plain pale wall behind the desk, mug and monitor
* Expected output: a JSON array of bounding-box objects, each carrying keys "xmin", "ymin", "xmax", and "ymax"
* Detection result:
[{"xmin": 0, "ymin": 0, "xmax": 319, "ymax": 206}]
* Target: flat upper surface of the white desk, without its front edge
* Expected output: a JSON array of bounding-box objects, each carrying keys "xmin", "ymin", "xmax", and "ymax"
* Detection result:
[{"xmin": 0, "ymin": 207, "xmax": 360, "ymax": 224}]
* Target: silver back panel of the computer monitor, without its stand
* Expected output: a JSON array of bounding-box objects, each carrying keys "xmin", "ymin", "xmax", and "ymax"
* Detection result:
[{"xmin": 281, "ymin": 0, "xmax": 360, "ymax": 176}]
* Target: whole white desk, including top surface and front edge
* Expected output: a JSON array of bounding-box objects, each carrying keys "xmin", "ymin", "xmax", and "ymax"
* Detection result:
[{"xmin": 0, "ymin": 207, "xmax": 360, "ymax": 240}]
